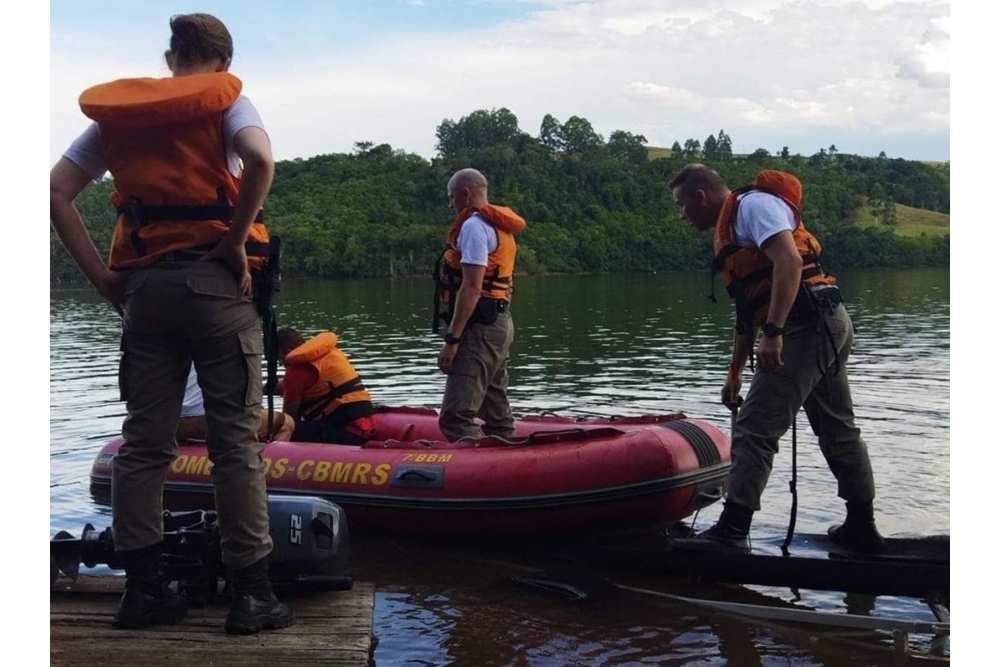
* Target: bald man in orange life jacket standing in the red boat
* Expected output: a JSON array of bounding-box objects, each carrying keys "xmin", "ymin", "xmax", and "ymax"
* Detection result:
[{"xmin": 438, "ymin": 169, "xmax": 527, "ymax": 441}]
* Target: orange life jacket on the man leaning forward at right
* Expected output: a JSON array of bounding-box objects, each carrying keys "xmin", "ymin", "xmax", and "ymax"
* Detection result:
[{"xmin": 712, "ymin": 169, "xmax": 836, "ymax": 329}]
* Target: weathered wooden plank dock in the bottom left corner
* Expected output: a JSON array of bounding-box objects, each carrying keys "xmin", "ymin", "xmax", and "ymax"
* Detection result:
[{"xmin": 49, "ymin": 576, "xmax": 375, "ymax": 667}]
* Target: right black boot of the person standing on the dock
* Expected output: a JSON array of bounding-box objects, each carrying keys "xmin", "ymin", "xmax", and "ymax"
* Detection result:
[{"xmin": 226, "ymin": 556, "xmax": 295, "ymax": 635}]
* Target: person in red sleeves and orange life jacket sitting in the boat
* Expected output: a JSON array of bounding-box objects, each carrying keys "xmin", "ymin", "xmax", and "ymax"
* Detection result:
[{"xmin": 277, "ymin": 327, "xmax": 376, "ymax": 445}]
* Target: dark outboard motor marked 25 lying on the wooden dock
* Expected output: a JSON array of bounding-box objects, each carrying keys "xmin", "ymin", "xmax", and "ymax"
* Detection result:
[{"xmin": 50, "ymin": 495, "xmax": 354, "ymax": 603}]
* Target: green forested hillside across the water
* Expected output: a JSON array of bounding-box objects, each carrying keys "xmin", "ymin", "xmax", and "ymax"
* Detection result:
[{"xmin": 50, "ymin": 109, "xmax": 950, "ymax": 283}]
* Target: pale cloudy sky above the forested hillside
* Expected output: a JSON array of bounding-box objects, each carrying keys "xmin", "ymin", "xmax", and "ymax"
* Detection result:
[{"xmin": 50, "ymin": 0, "xmax": 951, "ymax": 163}]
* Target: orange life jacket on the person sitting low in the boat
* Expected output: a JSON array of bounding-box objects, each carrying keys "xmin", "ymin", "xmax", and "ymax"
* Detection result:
[{"xmin": 285, "ymin": 331, "xmax": 374, "ymax": 423}]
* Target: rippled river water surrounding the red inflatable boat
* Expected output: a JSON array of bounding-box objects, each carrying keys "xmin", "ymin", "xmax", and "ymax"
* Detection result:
[{"xmin": 49, "ymin": 270, "xmax": 951, "ymax": 667}]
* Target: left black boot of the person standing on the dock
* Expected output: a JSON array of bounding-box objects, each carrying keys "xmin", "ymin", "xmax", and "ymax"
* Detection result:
[{"xmin": 112, "ymin": 543, "xmax": 187, "ymax": 629}]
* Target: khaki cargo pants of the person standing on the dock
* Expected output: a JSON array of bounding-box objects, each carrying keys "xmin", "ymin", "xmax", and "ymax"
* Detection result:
[{"xmin": 111, "ymin": 261, "xmax": 273, "ymax": 568}]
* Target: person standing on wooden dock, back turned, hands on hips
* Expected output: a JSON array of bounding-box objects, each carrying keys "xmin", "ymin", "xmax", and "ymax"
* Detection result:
[{"xmin": 49, "ymin": 14, "xmax": 295, "ymax": 634}]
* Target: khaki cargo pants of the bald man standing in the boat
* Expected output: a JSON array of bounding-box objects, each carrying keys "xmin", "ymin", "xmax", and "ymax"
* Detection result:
[{"xmin": 438, "ymin": 311, "xmax": 514, "ymax": 441}]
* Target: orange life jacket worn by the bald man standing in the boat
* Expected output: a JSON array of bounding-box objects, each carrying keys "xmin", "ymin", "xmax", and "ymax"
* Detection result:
[{"xmin": 435, "ymin": 204, "xmax": 528, "ymax": 325}]
